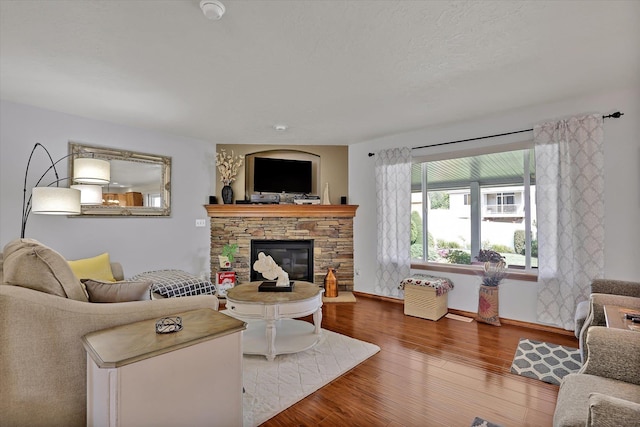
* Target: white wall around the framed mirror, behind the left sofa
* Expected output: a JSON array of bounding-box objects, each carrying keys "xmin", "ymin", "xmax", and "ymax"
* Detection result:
[{"xmin": 0, "ymin": 101, "xmax": 216, "ymax": 276}]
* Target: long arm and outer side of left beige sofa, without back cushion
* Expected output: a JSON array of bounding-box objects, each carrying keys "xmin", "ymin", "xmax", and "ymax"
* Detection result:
[{"xmin": 0, "ymin": 285, "xmax": 218, "ymax": 426}]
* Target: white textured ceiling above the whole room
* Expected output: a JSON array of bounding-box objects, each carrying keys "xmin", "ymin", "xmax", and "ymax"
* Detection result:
[{"xmin": 0, "ymin": 0, "xmax": 640, "ymax": 144}]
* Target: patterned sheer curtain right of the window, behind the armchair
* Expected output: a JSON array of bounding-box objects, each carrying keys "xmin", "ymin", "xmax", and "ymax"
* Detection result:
[{"xmin": 533, "ymin": 115, "xmax": 604, "ymax": 330}]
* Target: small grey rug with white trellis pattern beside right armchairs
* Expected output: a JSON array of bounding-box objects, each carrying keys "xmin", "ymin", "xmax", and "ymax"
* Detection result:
[{"xmin": 511, "ymin": 338, "xmax": 582, "ymax": 385}]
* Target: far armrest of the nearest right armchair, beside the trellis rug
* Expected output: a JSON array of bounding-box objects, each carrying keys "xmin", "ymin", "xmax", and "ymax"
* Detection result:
[{"xmin": 580, "ymin": 326, "xmax": 640, "ymax": 385}]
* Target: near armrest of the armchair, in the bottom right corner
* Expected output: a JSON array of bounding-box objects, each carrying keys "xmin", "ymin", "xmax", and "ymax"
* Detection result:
[{"xmin": 587, "ymin": 393, "xmax": 640, "ymax": 427}]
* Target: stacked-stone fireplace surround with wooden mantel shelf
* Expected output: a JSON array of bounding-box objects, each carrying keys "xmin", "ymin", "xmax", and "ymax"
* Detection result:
[{"xmin": 206, "ymin": 205, "xmax": 357, "ymax": 291}]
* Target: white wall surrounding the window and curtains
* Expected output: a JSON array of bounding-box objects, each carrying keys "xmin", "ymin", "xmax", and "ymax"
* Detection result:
[{"xmin": 349, "ymin": 85, "xmax": 640, "ymax": 328}]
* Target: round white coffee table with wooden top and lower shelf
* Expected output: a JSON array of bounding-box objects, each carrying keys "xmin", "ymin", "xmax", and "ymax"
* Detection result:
[{"xmin": 227, "ymin": 281, "xmax": 324, "ymax": 361}]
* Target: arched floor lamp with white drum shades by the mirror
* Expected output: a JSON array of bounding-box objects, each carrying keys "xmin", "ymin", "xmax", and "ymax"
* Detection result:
[{"xmin": 20, "ymin": 142, "xmax": 111, "ymax": 238}]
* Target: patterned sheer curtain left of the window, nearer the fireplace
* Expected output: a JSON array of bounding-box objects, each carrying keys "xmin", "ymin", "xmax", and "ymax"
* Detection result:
[{"xmin": 374, "ymin": 147, "xmax": 411, "ymax": 297}]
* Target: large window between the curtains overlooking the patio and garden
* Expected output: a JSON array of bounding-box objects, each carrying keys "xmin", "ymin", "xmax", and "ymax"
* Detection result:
[{"xmin": 411, "ymin": 149, "xmax": 538, "ymax": 270}]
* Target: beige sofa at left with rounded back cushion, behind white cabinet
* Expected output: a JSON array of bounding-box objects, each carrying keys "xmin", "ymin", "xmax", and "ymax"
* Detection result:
[{"xmin": 0, "ymin": 239, "xmax": 218, "ymax": 427}]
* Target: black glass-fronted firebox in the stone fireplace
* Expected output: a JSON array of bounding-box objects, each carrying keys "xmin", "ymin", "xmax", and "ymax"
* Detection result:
[{"xmin": 250, "ymin": 240, "xmax": 313, "ymax": 283}]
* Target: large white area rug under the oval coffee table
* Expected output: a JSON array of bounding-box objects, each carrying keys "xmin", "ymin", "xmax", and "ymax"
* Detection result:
[{"xmin": 242, "ymin": 329, "xmax": 380, "ymax": 427}]
